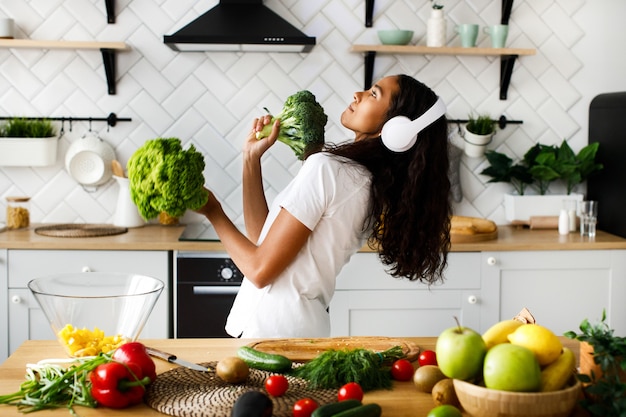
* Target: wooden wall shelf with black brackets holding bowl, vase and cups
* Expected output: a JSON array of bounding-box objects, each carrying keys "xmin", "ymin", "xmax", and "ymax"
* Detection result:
[{"xmin": 351, "ymin": 45, "xmax": 536, "ymax": 100}]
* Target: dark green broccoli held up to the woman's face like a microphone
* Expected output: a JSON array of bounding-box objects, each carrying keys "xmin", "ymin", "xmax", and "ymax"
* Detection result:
[{"xmin": 257, "ymin": 90, "xmax": 328, "ymax": 160}]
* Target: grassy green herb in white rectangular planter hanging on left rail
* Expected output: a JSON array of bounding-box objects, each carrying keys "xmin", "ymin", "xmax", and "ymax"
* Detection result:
[{"xmin": 0, "ymin": 117, "xmax": 58, "ymax": 166}]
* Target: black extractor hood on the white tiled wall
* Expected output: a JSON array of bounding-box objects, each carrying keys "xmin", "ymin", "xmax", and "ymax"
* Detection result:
[{"xmin": 163, "ymin": 0, "xmax": 315, "ymax": 52}]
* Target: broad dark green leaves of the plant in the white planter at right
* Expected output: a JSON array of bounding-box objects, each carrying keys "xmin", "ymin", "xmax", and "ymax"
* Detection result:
[{"xmin": 481, "ymin": 140, "xmax": 604, "ymax": 195}]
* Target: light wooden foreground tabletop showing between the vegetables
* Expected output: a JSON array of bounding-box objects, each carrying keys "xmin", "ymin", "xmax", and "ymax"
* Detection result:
[{"xmin": 0, "ymin": 337, "xmax": 579, "ymax": 417}]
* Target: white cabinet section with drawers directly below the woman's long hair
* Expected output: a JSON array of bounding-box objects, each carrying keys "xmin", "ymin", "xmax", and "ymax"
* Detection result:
[{"xmin": 330, "ymin": 252, "xmax": 484, "ymax": 337}]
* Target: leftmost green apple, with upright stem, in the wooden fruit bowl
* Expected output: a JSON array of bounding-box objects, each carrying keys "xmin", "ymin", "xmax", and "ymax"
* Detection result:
[{"xmin": 435, "ymin": 325, "xmax": 487, "ymax": 381}]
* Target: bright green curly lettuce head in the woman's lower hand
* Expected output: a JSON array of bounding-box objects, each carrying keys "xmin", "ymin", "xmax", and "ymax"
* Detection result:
[{"xmin": 127, "ymin": 138, "xmax": 208, "ymax": 220}]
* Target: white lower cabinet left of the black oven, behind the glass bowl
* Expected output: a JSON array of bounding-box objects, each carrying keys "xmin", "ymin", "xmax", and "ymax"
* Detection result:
[{"xmin": 5, "ymin": 250, "xmax": 171, "ymax": 360}]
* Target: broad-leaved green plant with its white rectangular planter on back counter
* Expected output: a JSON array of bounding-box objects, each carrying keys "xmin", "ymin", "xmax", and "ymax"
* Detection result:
[{"xmin": 481, "ymin": 140, "xmax": 603, "ymax": 222}]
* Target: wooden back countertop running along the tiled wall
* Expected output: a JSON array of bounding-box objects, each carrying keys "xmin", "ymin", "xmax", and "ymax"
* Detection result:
[{"xmin": 0, "ymin": 224, "xmax": 626, "ymax": 252}]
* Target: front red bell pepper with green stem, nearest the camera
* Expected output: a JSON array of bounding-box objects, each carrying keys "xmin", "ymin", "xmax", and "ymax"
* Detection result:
[{"xmin": 89, "ymin": 362, "xmax": 150, "ymax": 408}]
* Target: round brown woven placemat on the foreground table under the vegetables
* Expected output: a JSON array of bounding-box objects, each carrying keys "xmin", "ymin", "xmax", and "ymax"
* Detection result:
[{"xmin": 145, "ymin": 362, "xmax": 337, "ymax": 417}]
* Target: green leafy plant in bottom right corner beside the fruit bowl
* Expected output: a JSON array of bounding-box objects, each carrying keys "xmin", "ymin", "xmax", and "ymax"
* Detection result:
[{"xmin": 565, "ymin": 311, "xmax": 626, "ymax": 417}]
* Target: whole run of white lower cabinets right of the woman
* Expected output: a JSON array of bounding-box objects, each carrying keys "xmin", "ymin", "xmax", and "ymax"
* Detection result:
[{"xmin": 330, "ymin": 250, "xmax": 626, "ymax": 337}]
